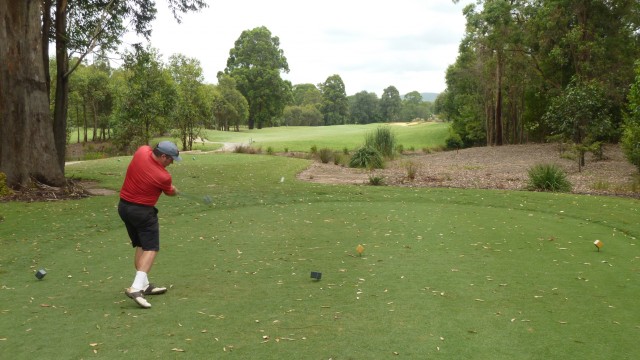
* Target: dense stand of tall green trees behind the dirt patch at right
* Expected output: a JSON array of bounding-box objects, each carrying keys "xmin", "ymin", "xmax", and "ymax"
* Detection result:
[{"xmin": 436, "ymin": 0, "xmax": 640, "ymax": 146}]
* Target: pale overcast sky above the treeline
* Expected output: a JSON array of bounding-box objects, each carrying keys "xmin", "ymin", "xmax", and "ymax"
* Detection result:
[{"xmin": 124, "ymin": 0, "xmax": 473, "ymax": 96}]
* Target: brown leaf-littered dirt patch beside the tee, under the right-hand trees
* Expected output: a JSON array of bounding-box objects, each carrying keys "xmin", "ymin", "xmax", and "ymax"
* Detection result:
[{"xmin": 298, "ymin": 144, "xmax": 638, "ymax": 197}]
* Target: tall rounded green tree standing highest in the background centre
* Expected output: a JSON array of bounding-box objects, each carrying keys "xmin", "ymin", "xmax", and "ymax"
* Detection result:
[{"xmin": 224, "ymin": 26, "xmax": 292, "ymax": 129}]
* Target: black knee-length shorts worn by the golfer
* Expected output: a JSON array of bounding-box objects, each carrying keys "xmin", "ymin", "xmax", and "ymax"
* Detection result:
[{"xmin": 118, "ymin": 199, "xmax": 160, "ymax": 251}]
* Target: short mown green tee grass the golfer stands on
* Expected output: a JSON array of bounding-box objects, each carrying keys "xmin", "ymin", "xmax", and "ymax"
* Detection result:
[{"xmin": 0, "ymin": 153, "xmax": 640, "ymax": 359}]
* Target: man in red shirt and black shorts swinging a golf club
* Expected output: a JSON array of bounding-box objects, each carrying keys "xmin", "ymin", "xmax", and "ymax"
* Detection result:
[{"xmin": 118, "ymin": 141, "xmax": 182, "ymax": 308}]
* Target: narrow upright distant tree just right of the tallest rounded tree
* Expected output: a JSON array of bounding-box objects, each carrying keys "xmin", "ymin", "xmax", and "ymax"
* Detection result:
[{"xmin": 318, "ymin": 74, "xmax": 349, "ymax": 125}]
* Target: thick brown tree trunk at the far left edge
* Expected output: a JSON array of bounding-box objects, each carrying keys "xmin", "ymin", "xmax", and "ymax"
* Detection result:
[{"xmin": 0, "ymin": 0, "xmax": 66, "ymax": 189}]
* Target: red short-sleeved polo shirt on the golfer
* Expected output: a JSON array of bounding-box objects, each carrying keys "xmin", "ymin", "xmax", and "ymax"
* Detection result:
[{"xmin": 120, "ymin": 145, "xmax": 173, "ymax": 206}]
